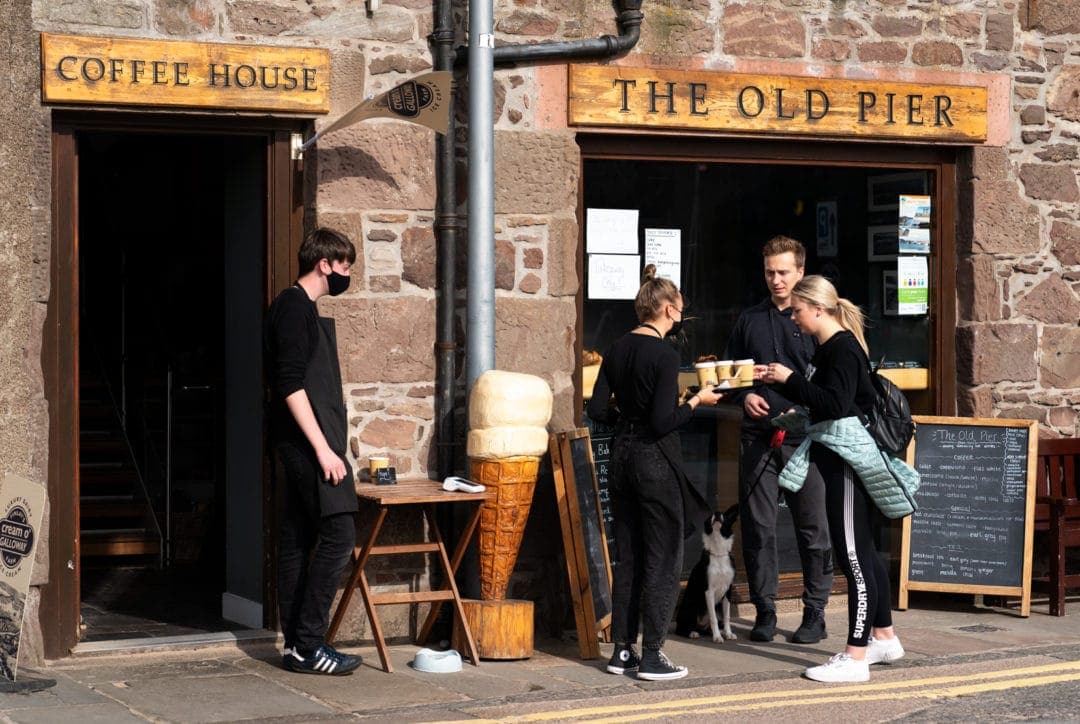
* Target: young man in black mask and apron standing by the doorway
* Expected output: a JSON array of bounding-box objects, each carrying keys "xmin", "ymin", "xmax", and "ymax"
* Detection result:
[{"xmin": 266, "ymin": 229, "xmax": 361, "ymax": 675}]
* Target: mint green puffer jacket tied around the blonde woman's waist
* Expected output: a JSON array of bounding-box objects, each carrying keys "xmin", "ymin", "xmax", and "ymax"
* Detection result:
[{"xmin": 779, "ymin": 416, "xmax": 919, "ymax": 518}]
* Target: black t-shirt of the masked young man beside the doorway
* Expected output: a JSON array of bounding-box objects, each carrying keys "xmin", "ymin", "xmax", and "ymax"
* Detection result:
[{"xmin": 264, "ymin": 286, "xmax": 319, "ymax": 442}]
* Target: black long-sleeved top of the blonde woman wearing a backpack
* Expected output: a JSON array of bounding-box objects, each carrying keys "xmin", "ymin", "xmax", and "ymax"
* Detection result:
[{"xmin": 780, "ymin": 330, "xmax": 877, "ymax": 423}]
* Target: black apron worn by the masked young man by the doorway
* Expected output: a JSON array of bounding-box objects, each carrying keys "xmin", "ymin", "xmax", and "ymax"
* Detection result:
[{"xmin": 303, "ymin": 317, "xmax": 360, "ymax": 517}]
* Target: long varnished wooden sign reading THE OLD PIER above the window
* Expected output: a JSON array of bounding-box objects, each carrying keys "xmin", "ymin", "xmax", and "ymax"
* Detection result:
[{"xmin": 567, "ymin": 65, "xmax": 987, "ymax": 143}]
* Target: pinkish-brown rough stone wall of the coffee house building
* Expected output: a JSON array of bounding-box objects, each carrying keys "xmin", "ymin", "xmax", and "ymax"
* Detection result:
[{"xmin": 0, "ymin": 0, "xmax": 1080, "ymax": 655}]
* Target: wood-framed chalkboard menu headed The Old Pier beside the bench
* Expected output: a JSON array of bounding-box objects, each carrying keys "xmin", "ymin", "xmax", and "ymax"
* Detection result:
[{"xmin": 899, "ymin": 416, "xmax": 1039, "ymax": 616}]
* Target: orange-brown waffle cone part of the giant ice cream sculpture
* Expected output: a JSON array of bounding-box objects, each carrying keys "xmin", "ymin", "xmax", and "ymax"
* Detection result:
[{"xmin": 469, "ymin": 456, "xmax": 540, "ymax": 601}]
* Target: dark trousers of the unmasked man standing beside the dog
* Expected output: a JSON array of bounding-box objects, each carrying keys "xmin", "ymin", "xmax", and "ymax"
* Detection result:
[{"xmin": 739, "ymin": 430, "xmax": 833, "ymax": 611}]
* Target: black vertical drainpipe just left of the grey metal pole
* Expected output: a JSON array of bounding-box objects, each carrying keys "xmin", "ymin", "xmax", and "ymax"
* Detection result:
[{"xmin": 431, "ymin": 0, "xmax": 461, "ymax": 480}]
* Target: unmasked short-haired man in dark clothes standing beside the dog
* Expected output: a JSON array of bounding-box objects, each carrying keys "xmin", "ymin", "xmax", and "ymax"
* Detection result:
[{"xmin": 727, "ymin": 237, "xmax": 833, "ymax": 643}]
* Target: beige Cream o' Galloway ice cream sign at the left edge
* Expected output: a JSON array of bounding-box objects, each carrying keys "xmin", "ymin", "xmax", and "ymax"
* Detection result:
[{"xmin": 0, "ymin": 474, "xmax": 45, "ymax": 681}]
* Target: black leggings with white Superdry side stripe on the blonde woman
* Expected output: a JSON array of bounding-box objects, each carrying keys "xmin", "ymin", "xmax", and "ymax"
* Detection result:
[{"xmin": 811, "ymin": 443, "xmax": 892, "ymax": 646}]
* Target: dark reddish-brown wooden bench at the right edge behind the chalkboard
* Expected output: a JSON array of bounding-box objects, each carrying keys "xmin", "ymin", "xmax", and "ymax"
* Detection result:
[{"xmin": 1031, "ymin": 438, "xmax": 1080, "ymax": 616}]
